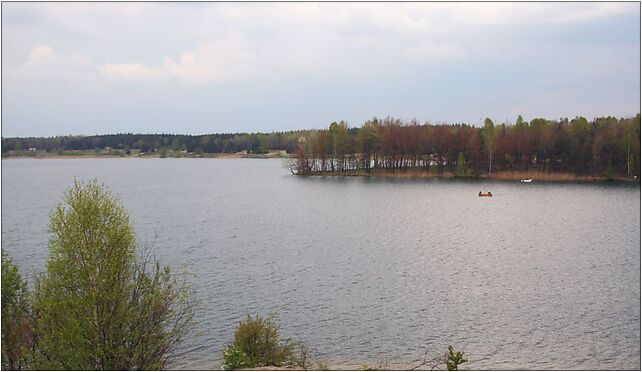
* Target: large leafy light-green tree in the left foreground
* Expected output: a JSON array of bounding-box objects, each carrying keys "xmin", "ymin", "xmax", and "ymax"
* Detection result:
[{"xmin": 34, "ymin": 181, "xmax": 193, "ymax": 370}]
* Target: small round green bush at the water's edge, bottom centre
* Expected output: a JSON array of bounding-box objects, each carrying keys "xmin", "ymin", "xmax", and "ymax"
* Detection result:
[{"xmin": 223, "ymin": 314, "xmax": 308, "ymax": 370}]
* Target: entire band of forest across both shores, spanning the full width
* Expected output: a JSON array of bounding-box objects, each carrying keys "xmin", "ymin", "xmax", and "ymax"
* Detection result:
[{"xmin": 2, "ymin": 113, "xmax": 640, "ymax": 178}]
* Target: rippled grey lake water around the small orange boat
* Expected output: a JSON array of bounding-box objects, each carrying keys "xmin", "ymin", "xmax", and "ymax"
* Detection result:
[{"xmin": 2, "ymin": 159, "xmax": 640, "ymax": 370}]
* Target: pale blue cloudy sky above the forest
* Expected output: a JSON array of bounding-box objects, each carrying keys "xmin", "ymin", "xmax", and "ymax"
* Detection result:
[{"xmin": 2, "ymin": 2, "xmax": 640, "ymax": 137}]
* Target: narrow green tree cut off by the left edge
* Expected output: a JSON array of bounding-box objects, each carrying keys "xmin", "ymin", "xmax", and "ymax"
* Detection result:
[{"xmin": 2, "ymin": 252, "xmax": 33, "ymax": 370}]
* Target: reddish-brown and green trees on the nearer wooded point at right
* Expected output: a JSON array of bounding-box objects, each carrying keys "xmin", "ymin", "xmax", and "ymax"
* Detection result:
[{"xmin": 291, "ymin": 114, "xmax": 640, "ymax": 178}]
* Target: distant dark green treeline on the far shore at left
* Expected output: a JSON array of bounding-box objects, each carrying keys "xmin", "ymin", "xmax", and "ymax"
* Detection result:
[{"xmin": 2, "ymin": 131, "xmax": 304, "ymax": 154}]
